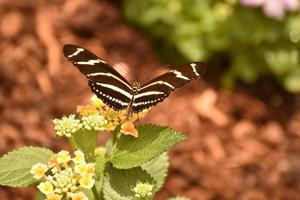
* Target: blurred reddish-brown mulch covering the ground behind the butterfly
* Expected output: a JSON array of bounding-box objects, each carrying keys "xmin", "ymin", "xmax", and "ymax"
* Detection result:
[{"xmin": 0, "ymin": 0, "xmax": 300, "ymax": 200}]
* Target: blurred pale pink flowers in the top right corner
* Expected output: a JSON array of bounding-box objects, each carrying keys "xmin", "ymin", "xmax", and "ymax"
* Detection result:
[{"xmin": 241, "ymin": 0, "xmax": 300, "ymax": 20}]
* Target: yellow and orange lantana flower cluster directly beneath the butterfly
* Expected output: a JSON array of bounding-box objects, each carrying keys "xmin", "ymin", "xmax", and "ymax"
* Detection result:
[{"xmin": 53, "ymin": 95, "xmax": 148, "ymax": 137}]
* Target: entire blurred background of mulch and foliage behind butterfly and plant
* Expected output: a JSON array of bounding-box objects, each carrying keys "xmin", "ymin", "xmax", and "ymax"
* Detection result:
[{"xmin": 0, "ymin": 0, "xmax": 300, "ymax": 200}]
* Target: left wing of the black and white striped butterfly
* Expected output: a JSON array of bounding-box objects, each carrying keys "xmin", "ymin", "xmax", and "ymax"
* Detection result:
[{"xmin": 63, "ymin": 44, "xmax": 132, "ymax": 110}]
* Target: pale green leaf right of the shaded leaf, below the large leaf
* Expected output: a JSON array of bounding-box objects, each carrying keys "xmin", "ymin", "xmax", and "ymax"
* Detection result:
[{"xmin": 141, "ymin": 152, "xmax": 170, "ymax": 192}]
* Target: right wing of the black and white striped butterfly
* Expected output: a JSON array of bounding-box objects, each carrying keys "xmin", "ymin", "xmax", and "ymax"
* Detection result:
[{"xmin": 132, "ymin": 62, "xmax": 205, "ymax": 112}]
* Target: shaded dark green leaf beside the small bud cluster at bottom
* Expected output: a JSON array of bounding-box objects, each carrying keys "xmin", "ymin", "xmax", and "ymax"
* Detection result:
[{"xmin": 103, "ymin": 165, "xmax": 154, "ymax": 200}]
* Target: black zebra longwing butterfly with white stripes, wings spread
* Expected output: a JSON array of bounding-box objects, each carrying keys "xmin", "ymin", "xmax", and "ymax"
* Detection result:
[{"xmin": 63, "ymin": 44, "xmax": 205, "ymax": 118}]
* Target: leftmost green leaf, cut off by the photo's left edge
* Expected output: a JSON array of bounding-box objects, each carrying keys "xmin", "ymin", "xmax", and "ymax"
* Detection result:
[{"xmin": 0, "ymin": 147, "xmax": 53, "ymax": 187}]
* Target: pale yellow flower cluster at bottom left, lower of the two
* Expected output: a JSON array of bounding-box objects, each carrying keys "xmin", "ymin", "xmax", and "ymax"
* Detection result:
[{"xmin": 30, "ymin": 150, "xmax": 95, "ymax": 200}]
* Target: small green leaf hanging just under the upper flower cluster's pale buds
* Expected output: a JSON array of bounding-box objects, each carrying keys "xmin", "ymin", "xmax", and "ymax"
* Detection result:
[{"xmin": 72, "ymin": 130, "xmax": 97, "ymax": 161}]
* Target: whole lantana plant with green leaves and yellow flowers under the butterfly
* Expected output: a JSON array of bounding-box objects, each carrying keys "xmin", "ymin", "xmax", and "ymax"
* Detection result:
[{"xmin": 0, "ymin": 97, "xmax": 190, "ymax": 200}]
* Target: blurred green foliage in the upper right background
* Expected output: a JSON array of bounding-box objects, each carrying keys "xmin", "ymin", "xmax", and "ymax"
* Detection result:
[{"xmin": 123, "ymin": 0, "xmax": 300, "ymax": 92}]
